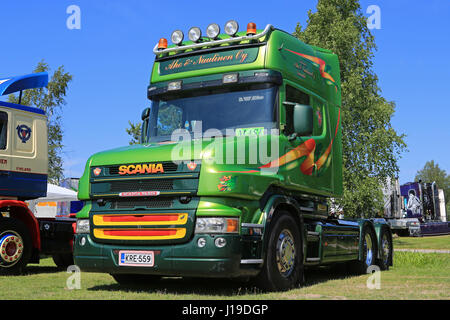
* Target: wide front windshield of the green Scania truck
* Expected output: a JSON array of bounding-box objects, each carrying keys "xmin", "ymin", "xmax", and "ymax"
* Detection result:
[{"xmin": 149, "ymin": 84, "xmax": 277, "ymax": 142}]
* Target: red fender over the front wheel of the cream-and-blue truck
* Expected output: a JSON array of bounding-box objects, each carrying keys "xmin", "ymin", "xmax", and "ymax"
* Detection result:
[{"xmin": 0, "ymin": 200, "xmax": 41, "ymax": 250}]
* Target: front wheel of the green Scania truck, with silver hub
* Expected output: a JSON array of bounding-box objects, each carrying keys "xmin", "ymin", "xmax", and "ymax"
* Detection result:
[{"xmin": 256, "ymin": 211, "xmax": 304, "ymax": 291}]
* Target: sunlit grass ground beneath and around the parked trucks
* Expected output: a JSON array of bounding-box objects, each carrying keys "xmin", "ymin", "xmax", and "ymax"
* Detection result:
[{"xmin": 0, "ymin": 252, "xmax": 450, "ymax": 300}]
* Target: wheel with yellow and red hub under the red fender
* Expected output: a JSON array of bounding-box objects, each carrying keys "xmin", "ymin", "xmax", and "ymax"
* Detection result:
[{"xmin": 0, "ymin": 218, "xmax": 32, "ymax": 275}]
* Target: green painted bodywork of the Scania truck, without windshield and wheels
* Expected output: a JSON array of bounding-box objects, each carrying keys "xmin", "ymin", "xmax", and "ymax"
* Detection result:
[{"xmin": 74, "ymin": 29, "xmax": 390, "ymax": 277}]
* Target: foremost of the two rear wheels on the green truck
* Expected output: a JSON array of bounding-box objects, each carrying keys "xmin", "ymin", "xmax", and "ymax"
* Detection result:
[{"xmin": 351, "ymin": 225, "xmax": 377, "ymax": 274}]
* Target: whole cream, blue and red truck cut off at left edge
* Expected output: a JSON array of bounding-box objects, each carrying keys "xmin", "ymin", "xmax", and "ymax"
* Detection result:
[{"xmin": 0, "ymin": 72, "xmax": 73, "ymax": 274}]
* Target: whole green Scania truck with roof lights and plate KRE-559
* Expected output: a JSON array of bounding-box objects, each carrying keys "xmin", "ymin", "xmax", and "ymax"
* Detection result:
[{"xmin": 74, "ymin": 20, "xmax": 393, "ymax": 290}]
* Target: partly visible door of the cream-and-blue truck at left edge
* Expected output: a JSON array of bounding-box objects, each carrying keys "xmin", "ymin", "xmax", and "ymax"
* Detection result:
[{"xmin": 0, "ymin": 107, "xmax": 11, "ymax": 198}]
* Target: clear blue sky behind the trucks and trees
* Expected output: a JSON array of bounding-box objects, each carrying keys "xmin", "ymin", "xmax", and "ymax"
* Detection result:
[{"xmin": 0, "ymin": 0, "xmax": 450, "ymax": 183}]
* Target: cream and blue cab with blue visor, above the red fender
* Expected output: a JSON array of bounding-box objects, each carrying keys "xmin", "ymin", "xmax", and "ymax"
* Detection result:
[{"xmin": 0, "ymin": 74, "xmax": 48, "ymax": 200}]
